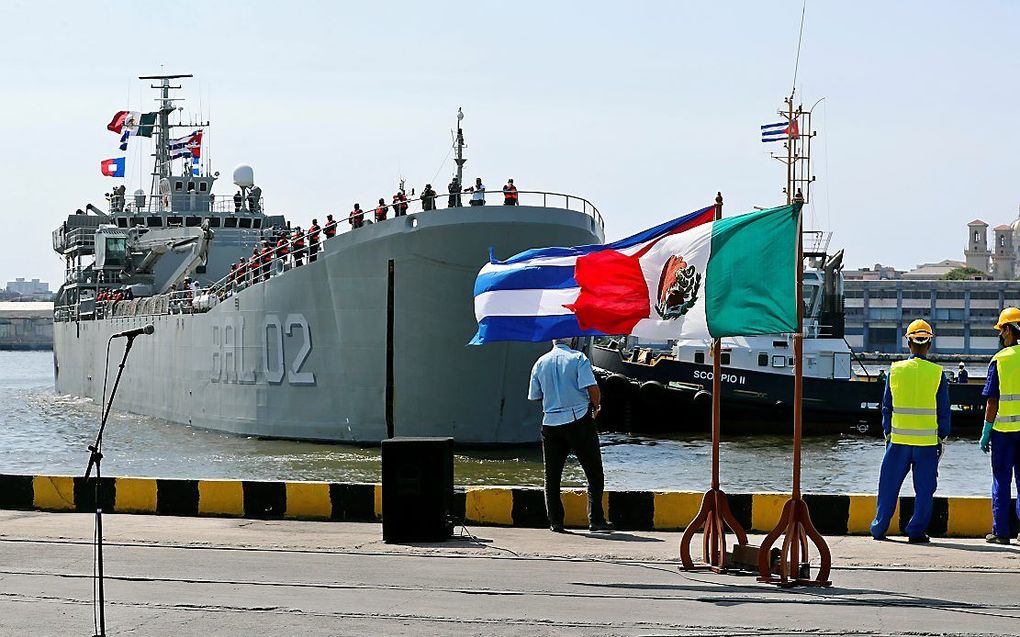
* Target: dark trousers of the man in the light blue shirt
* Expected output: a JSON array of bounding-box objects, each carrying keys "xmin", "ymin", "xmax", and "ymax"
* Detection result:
[{"xmin": 542, "ymin": 413, "xmax": 606, "ymax": 525}]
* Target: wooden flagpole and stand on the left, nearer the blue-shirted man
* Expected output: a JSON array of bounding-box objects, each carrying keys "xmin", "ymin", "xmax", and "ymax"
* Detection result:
[{"xmin": 680, "ymin": 193, "xmax": 748, "ymax": 573}]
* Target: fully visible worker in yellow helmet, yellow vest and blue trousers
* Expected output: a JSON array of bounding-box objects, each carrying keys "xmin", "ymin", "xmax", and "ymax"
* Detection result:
[{"xmin": 871, "ymin": 319, "xmax": 951, "ymax": 543}]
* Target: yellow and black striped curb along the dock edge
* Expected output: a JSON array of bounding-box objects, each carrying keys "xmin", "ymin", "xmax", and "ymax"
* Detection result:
[{"xmin": 0, "ymin": 474, "xmax": 1018, "ymax": 537}]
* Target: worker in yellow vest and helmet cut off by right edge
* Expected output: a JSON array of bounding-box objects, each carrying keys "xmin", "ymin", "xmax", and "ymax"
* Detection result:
[{"xmin": 981, "ymin": 308, "xmax": 1020, "ymax": 544}]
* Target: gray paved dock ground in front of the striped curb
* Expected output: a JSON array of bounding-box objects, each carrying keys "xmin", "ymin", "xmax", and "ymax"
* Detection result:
[{"xmin": 0, "ymin": 512, "xmax": 1020, "ymax": 636}]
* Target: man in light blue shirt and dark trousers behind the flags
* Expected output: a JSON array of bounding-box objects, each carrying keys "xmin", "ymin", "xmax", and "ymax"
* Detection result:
[{"xmin": 527, "ymin": 338, "xmax": 612, "ymax": 533}]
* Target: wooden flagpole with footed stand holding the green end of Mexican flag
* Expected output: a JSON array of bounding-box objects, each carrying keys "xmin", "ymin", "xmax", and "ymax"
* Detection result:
[{"xmin": 758, "ymin": 191, "xmax": 832, "ymax": 586}]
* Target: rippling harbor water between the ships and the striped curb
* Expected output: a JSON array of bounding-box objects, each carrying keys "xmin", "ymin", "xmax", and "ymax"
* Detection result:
[{"xmin": 0, "ymin": 352, "xmax": 990, "ymax": 495}]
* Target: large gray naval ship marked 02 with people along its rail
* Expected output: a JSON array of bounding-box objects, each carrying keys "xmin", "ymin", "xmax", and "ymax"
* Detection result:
[{"xmin": 53, "ymin": 75, "xmax": 604, "ymax": 445}]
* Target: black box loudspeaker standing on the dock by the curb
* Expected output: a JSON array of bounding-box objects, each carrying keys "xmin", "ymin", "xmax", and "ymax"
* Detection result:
[{"xmin": 383, "ymin": 438, "xmax": 453, "ymax": 542}]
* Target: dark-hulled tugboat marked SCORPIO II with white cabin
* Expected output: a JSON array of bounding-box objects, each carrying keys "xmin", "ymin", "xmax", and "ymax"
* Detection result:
[{"xmin": 591, "ymin": 96, "xmax": 984, "ymax": 435}]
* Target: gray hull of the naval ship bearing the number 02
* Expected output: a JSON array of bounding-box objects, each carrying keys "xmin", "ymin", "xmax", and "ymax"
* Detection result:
[{"xmin": 54, "ymin": 207, "xmax": 603, "ymax": 445}]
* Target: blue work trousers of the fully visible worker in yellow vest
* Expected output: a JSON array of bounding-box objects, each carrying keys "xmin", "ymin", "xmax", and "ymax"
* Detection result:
[{"xmin": 871, "ymin": 442, "xmax": 940, "ymax": 537}]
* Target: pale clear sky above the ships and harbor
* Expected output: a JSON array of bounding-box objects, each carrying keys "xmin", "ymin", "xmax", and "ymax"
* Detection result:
[{"xmin": 0, "ymin": 0, "xmax": 1020, "ymax": 287}]
